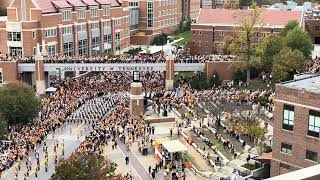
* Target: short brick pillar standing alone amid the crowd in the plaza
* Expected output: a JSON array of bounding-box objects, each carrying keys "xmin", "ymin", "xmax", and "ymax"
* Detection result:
[{"xmin": 130, "ymin": 82, "xmax": 144, "ymax": 117}]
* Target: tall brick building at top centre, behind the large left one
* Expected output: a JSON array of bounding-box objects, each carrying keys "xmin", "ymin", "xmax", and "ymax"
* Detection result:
[{"xmin": 123, "ymin": 0, "xmax": 200, "ymax": 44}]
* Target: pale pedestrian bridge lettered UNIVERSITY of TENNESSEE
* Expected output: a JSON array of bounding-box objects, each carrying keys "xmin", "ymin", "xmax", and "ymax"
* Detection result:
[{"xmin": 18, "ymin": 63, "xmax": 205, "ymax": 73}]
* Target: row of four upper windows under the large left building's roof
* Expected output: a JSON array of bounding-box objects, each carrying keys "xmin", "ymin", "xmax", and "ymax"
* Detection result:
[{"xmin": 62, "ymin": 6, "xmax": 110, "ymax": 21}]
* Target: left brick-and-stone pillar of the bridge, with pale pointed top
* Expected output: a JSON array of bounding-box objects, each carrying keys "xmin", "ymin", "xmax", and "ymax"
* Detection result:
[{"xmin": 35, "ymin": 43, "xmax": 46, "ymax": 95}]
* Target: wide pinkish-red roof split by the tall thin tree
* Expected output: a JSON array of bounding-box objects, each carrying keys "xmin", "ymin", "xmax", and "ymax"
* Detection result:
[{"xmin": 196, "ymin": 9, "xmax": 303, "ymax": 27}]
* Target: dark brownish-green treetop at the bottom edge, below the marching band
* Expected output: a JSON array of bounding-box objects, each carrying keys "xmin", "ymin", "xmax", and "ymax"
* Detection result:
[{"xmin": 52, "ymin": 153, "xmax": 120, "ymax": 180}]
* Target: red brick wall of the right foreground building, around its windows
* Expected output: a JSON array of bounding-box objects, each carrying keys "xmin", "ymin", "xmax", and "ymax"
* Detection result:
[{"xmin": 271, "ymin": 84, "xmax": 320, "ymax": 176}]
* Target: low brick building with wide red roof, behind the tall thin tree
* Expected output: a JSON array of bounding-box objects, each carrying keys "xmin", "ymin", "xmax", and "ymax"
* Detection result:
[{"xmin": 191, "ymin": 9, "xmax": 304, "ymax": 54}]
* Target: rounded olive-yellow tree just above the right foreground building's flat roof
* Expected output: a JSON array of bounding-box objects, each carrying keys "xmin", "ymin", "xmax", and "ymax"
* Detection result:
[{"xmin": 272, "ymin": 47, "xmax": 307, "ymax": 81}]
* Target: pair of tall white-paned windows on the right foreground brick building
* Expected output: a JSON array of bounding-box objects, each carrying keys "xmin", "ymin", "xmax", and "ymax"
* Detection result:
[{"xmin": 282, "ymin": 105, "xmax": 320, "ymax": 137}]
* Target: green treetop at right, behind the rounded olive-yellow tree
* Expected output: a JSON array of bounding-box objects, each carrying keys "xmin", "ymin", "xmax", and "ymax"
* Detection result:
[{"xmin": 285, "ymin": 27, "xmax": 313, "ymax": 58}]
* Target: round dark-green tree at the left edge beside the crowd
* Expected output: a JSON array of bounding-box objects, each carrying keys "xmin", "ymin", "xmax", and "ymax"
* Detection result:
[{"xmin": 0, "ymin": 82, "xmax": 40, "ymax": 125}]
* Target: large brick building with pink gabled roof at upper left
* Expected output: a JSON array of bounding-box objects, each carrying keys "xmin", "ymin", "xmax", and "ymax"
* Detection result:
[{"xmin": 0, "ymin": 0, "xmax": 130, "ymax": 56}]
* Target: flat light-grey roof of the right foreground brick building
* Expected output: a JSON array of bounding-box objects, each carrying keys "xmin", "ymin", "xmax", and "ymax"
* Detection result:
[{"xmin": 279, "ymin": 74, "xmax": 320, "ymax": 93}]
